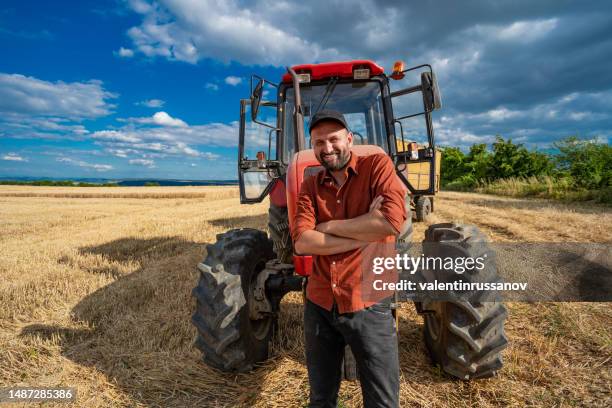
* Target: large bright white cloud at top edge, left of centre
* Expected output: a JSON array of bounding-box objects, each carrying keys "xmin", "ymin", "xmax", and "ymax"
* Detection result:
[{"xmin": 123, "ymin": 0, "xmax": 341, "ymax": 65}]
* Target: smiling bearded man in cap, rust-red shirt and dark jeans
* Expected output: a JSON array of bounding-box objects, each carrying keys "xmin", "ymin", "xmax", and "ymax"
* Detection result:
[{"xmin": 291, "ymin": 110, "xmax": 406, "ymax": 407}]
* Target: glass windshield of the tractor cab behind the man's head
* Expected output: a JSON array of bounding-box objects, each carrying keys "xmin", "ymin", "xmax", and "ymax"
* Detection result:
[{"xmin": 283, "ymin": 81, "xmax": 388, "ymax": 159}]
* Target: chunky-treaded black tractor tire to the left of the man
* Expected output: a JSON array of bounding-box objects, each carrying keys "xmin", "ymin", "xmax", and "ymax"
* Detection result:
[{"xmin": 191, "ymin": 228, "xmax": 276, "ymax": 372}]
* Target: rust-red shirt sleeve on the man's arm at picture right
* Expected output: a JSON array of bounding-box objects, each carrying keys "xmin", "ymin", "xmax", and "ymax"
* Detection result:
[{"xmin": 372, "ymin": 154, "xmax": 406, "ymax": 233}]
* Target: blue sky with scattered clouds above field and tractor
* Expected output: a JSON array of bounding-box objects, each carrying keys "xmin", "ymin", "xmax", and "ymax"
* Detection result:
[{"xmin": 0, "ymin": 0, "xmax": 612, "ymax": 179}]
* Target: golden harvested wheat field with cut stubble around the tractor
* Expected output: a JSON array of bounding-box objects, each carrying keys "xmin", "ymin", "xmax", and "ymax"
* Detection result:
[{"xmin": 0, "ymin": 186, "xmax": 612, "ymax": 407}]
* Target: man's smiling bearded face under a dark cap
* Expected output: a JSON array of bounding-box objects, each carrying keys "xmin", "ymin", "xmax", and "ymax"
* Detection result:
[{"xmin": 310, "ymin": 121, "xmax": 353, "ymax": 171}]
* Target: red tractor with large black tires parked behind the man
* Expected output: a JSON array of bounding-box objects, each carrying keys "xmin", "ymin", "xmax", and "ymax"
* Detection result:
[{"xmin": 192, "ymin": 60, "xmax": 507, "ymax": 379}]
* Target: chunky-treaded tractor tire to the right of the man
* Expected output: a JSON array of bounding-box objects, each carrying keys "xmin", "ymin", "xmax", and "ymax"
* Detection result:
[{"xmin": 417, "ymin": 224, "xmax": 508, "ymax": 380}]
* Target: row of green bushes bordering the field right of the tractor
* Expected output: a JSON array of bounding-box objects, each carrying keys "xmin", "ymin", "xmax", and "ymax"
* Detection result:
[{"xmin": 442, "ymin": 136, "xmax": 612, "ymax": 203}]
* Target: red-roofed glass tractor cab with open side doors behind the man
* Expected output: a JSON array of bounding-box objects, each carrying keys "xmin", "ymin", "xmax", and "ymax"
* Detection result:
[{"xmin": 238, "ymin": 60, "xmax": 440, "ymax": 222}]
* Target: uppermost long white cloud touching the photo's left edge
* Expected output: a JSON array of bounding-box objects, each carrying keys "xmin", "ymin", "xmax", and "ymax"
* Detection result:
[{"xmin": 0, "ymin": 73, "xmax": 117, "ymax": 120}]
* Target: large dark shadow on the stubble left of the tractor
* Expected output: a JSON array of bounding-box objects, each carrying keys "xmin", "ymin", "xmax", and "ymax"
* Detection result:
[{"xmin": 20, "ymin": 234, "xmax": 450, "ymax": 407}]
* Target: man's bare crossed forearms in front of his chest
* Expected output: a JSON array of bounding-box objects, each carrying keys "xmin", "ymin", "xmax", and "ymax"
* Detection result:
[{"xmin": 295, "ymin": 196, "xmax": 398, "ymax": 255}]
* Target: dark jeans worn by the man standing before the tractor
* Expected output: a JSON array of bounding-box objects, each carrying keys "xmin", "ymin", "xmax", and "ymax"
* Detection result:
[{"xmin": 304, "ymin": 300, "xmax": 399, "ymax": 408}]
